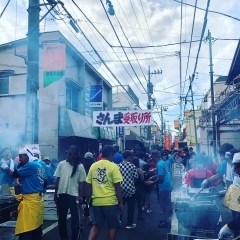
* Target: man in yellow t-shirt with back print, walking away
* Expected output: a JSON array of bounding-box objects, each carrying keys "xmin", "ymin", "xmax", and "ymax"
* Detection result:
[{"xmin": 86, "ymin": 145, "xmax": 123, "ymax": 240}]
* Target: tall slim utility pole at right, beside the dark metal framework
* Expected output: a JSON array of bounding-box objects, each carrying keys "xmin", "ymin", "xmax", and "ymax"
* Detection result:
[{"xmin": 207, "ymin": 30, "xmax": 217, "ymax": 157}]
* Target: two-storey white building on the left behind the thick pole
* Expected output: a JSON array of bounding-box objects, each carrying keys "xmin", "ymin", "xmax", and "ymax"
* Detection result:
[{"xmin": 0, "ymin": 31, "xmax": 115, "ymax": 159}]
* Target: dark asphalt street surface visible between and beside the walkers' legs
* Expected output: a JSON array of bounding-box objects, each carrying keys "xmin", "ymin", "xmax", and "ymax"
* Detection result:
[{"xmin": 42, "ymin": 192, "xmax": 170, "ymax": 240}]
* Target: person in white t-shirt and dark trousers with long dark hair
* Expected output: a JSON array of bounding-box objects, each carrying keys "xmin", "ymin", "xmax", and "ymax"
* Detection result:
[{"xmin": 54, "ymin": 146, "xmax": 86, "ymax": 240}]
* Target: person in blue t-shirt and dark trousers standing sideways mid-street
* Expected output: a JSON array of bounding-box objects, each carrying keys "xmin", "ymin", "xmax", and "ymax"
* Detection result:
[{"xmin": 151, "ymin": 151, "xmax": 173, "ymax": 228}]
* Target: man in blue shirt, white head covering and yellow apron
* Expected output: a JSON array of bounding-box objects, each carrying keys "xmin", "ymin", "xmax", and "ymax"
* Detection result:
[{"xmin": 5, "ymin": 148, "xmax": 44, "ymax": 240}]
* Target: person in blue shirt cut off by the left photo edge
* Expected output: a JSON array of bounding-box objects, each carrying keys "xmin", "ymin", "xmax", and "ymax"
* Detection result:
[{"xmin": 0, "ymin": 148, "xmax": 18, "ymax": 195}]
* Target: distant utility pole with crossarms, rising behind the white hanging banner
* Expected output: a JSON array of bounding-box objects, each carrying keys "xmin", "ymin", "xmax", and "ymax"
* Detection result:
[{"xmin": 147, "ymin": 66, "xmax": 162, "ymax": 149}]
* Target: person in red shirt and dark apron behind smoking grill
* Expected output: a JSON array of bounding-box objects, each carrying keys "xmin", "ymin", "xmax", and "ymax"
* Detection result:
[{"xmin": 185, "ymin": 155, "xmax": 213, "ymax": 188}]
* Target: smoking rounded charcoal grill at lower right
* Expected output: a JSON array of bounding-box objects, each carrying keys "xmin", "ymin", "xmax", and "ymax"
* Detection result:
[{"xmin": 175, "ymin": 199, "xmax": 220, "ymax": 230}]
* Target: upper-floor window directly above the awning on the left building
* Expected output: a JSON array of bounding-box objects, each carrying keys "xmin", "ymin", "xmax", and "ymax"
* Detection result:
[{"xmin": 66, "ymin": 84, "xmax": 79, "ymax": 112}]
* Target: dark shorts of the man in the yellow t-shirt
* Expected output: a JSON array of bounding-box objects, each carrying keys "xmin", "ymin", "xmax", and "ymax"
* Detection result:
[{"xmin": 92, "ymin": 205, "xmax": 120, "ymax": 228}]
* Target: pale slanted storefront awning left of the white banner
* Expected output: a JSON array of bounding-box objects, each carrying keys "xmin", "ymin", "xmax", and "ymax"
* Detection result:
[{"xmin": 59, "ymin": 108, "xmax": 97, "ymax": 139}]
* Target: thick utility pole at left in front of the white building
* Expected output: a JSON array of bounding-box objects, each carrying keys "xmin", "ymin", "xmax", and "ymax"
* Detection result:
[{"xmin": 25, "ymin": 0, "xmax": 40, "ymax": 144}]
